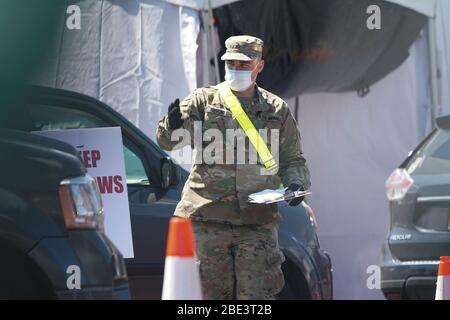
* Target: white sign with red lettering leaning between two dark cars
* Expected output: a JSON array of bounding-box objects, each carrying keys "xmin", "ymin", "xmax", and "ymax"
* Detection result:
[{"xmin": 35, "ymin": 127, "xmax": 134, "ymax": 258}]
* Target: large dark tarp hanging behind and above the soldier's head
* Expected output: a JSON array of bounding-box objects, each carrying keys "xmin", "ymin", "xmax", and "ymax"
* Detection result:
[{"xmin": 214, "ymin": 0, "xmax": 426, "ymax": 97}]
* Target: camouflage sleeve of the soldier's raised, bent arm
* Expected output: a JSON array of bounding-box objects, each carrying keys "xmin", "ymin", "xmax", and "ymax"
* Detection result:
[{"xmin": 156, "ymin": 91, "xmax": 203, "ymax": 151}]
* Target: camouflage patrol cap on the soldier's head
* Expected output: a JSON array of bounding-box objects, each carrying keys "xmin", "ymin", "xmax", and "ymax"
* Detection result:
[{"xmin": 220, "ymin": 36, "xmax": 264, "ymax": 61}]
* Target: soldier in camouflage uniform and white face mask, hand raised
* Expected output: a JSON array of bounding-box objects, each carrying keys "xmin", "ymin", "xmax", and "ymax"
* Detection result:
[{"xmin": 157, "ymin": 36, "xmax": 310, "ymax": 299}]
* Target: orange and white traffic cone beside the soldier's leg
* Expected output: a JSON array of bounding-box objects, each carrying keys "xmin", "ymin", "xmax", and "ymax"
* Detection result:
[{"xmin": 162, "ymin": 217, "xmax": 202, "ymax": 300}]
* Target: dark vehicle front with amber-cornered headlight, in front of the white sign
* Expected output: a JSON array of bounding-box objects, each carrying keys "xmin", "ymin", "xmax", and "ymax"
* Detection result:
[{"xmin": 0, "ymin": 129, "xmax": 129, "ymax": 299}]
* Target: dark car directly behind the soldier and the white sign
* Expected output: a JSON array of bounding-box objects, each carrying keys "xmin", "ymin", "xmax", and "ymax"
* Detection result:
[{"xmin": 14, "ymin": 87, "xmax": 332, "ymax": 299}]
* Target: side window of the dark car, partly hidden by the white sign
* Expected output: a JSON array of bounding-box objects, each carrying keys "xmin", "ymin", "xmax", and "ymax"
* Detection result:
[{"xmin": 28, "ymin": 105, "xmax": 149, "ymax": 185}]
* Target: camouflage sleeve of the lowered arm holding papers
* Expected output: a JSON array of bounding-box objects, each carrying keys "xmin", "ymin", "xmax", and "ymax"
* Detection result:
[{"xmin": 278, "ymin": 104, "xmax": 311, "ymax": 190}]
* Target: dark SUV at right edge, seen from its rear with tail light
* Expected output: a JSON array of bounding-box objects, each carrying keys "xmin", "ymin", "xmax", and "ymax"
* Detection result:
[{"xmin": 381, "ymin": 115, "xmax": 450, "ymax": 299}]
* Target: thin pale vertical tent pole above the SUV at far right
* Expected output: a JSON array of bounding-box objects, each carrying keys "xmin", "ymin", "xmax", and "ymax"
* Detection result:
[{"xmin": 428, "ymin": 17, "xmax": 439, "ymax": 129}]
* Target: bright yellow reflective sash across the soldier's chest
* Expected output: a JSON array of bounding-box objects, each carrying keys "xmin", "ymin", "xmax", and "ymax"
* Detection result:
[{"xmin": 217, "ymin": 82, "xmax": 278, "ymax": 171}]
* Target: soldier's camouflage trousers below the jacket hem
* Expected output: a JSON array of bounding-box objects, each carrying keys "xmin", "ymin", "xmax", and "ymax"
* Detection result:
[{"xmin": 192, "ymin": 221, "xmax": 285, "ymax": 300}]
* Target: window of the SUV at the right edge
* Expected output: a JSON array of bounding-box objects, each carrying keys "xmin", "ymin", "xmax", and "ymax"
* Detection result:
[{"xmin": 408, "ymin": 130, "xmax": 450, "ymax": 174}]
